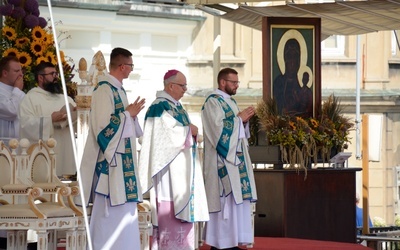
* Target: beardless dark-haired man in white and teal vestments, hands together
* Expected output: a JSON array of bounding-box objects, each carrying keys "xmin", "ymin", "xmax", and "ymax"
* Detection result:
[{"xmin": 79, "ymin": 48, "xmax": 145, "ymax": 250}]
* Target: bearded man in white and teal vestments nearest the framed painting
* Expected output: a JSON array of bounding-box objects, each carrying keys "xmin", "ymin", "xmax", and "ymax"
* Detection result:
[{"xmin": 201, "ymin": 68, "xmax": 257, "ymax": 249}]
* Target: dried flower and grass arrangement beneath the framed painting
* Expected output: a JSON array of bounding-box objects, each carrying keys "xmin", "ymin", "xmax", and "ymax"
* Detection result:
[{"xmin": 256, "ymin": 95, "xmax": 353, "ymax": 168}]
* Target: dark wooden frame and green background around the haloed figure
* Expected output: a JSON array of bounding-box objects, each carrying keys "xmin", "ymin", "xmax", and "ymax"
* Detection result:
[{"xmin": 262, "ymin": 17, "xmax": 321, "ymax": 117}]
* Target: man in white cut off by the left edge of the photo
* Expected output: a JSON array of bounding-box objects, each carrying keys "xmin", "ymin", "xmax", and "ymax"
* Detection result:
[{"xmin": 0, "ymin": 56, "xmax": 25, "ymax": 143}]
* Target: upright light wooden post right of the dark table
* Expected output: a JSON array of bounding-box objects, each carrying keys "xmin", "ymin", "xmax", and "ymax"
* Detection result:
[{"xmin": 362, "ymin": 115, "xmax": 369, "ymax": 235}]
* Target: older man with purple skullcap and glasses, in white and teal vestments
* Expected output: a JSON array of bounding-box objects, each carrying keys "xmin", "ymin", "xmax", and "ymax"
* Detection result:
[{"xmin": 139, "ymin": 70, "xmax": 209, "ymax": 250}]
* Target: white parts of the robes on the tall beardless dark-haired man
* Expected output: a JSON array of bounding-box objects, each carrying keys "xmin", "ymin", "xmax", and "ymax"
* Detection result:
[{"xmin": 78, "ymin": 74, "xmax": 142, "ymax": 250}]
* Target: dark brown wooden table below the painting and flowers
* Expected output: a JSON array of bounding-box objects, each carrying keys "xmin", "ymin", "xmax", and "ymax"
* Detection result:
[{"xmin": 254, "ymin": 168, "xmax": 361, "ymax": 243}]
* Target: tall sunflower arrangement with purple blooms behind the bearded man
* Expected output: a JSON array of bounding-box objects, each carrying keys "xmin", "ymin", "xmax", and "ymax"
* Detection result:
[{"xmin": 0, "ymin": 0, "xmax": 76, "ymax": 98}]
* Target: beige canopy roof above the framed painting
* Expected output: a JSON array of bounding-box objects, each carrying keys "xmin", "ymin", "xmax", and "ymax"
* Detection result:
[{"xmin": 193, "ymin": 0, "xmax": 400, "ymax": 38}]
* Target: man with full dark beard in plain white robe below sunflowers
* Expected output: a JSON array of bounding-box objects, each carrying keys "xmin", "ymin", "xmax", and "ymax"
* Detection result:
[{"xmin": 20, "ymin": 62, "xmax": 76, "ymax": 176}]
